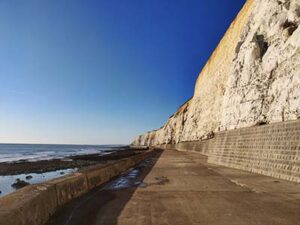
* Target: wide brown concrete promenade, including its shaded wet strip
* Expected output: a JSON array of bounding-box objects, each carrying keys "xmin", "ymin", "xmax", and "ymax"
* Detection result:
[{"xmin": 48, "ymin": 150, "xmax": 300, "ymax": 225}]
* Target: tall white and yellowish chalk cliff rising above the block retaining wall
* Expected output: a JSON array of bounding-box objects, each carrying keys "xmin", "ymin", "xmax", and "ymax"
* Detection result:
[{"xmin": 133, "ymin": 0, "xmax": 300, "ymax": 145}]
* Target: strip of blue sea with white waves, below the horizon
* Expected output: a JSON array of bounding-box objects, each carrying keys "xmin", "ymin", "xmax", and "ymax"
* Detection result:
[{"xmin": 0, "ymin": 144, "xmax": 122, "ymax": 163}]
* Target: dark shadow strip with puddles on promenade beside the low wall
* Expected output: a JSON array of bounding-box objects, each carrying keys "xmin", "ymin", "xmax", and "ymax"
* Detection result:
[{"xmin": 47, "ymin": 150, "xmax": 163, "ymax": 225}]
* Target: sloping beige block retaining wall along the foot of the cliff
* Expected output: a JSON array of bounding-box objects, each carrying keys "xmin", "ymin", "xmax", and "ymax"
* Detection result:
[{"xmin": 159, "ymin": 120, "xmax": 300, "ymax": 182}]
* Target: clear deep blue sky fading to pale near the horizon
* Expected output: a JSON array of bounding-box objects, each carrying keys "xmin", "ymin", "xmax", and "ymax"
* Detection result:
[{"xmin": 0, "ymin": 0, "xmax": 245, "ymax": 144}]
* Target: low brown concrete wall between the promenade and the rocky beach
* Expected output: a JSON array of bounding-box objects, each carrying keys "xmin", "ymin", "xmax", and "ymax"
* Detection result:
[{"xmin": 0, "ymin": 151, "xmax": 154, "ymax": 225}]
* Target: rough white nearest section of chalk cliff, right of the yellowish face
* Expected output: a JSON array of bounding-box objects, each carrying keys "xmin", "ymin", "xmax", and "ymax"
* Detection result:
[{"xmin": 221, "ymin": 0, "xmax": 300, "ymax": 130}]
